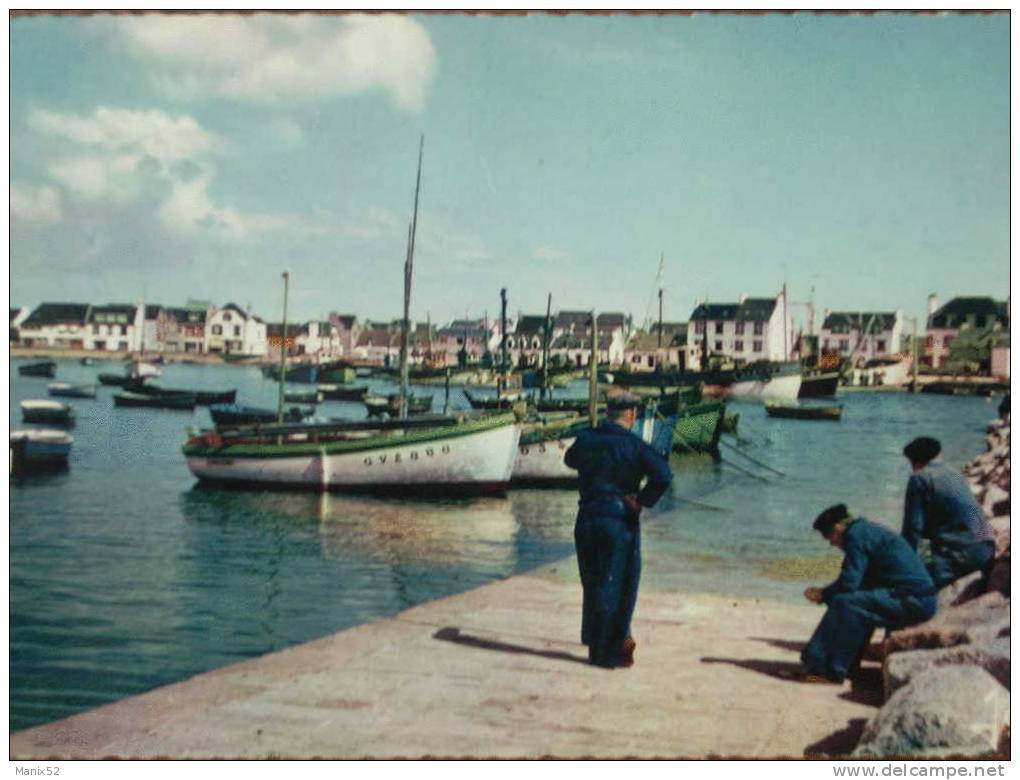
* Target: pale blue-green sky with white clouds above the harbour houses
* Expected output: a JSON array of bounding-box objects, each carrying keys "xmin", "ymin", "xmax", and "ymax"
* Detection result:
[{"xmin": 9, "ymin": 12, "xmax": 1010, "ymax": 328}]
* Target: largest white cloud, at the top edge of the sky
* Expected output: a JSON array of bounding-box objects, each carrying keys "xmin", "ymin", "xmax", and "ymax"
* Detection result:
[{"xmin": 117, "ymin": 13, "xmax": 436, "ymax": 110}]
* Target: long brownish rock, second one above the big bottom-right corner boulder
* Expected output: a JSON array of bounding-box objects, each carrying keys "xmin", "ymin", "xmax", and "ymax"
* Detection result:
[{"xmin": 885, "ymin": 591, "xmax": 1010, "ymax": 655}]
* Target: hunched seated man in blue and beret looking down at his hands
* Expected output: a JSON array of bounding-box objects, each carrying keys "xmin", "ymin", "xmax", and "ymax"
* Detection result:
[{"xmin": 801, "ymin": 504, "xmax": 935, "ymax": 683}]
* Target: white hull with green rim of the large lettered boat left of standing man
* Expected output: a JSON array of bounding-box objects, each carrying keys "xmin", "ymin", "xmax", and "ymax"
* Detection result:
[{"xmin": 185, "ymin": 417, "xmax": 520, "ymax": 495}]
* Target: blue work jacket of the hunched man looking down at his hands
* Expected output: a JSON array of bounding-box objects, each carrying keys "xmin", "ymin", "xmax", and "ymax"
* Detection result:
[{"xmin": 822, "ymin": 517, "xmax": 935, "ymax": 604}]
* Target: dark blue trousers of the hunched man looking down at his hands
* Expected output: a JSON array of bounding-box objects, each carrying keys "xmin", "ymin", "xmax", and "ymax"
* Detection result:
[{"xmin": 801, "ymin": 588, "xmax": 935, "ymax": 680}]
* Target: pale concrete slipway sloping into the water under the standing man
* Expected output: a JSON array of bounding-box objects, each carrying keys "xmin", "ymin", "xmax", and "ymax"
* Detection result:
[{"xmin": 10, "ymin": 560, "xmax": 878, "ymax": 759}]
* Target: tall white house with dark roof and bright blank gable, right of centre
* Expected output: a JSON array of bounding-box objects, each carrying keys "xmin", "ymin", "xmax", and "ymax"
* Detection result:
[{"xmin": 687, "ymin": 293, "xmax": 794, "ymax": 363}]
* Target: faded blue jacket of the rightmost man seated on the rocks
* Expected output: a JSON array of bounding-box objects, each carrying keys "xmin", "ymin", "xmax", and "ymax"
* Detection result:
[{"xmin": 903, "ymin": 463, "xmax": 995, "ymax": 553}]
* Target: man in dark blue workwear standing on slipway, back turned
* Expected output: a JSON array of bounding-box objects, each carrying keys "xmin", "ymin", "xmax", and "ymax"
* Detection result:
[{"xmin": 564, "ymin": 394, "xmax": 672, "ymax": 669}]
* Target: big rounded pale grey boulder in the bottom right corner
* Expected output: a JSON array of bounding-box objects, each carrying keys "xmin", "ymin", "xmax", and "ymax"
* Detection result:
[{"xmin": 853, "ymin": 666, "xmax": 1010, "ymax": 759}]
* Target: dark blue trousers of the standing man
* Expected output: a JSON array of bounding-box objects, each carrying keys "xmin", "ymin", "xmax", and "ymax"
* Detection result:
[{"xmin": 574, "ymin": 509, "xmax": 641, "ymax": 668}]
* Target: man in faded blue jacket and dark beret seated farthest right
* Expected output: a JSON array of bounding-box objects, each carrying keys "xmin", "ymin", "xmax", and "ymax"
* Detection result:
[{"xmin": 903, "ymin": 436, "xmax": 996, "ymax": 588}]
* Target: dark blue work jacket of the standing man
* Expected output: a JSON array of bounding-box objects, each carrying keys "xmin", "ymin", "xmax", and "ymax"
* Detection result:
[{"xmin": 563, "ymin": 421, "xmax": 673, "ymax": 507}]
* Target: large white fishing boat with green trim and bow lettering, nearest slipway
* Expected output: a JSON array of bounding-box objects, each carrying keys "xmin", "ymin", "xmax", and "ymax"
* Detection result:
[{"xmin": 184, "ymin": 407, "xmax": 520, "ymax": 496}]
